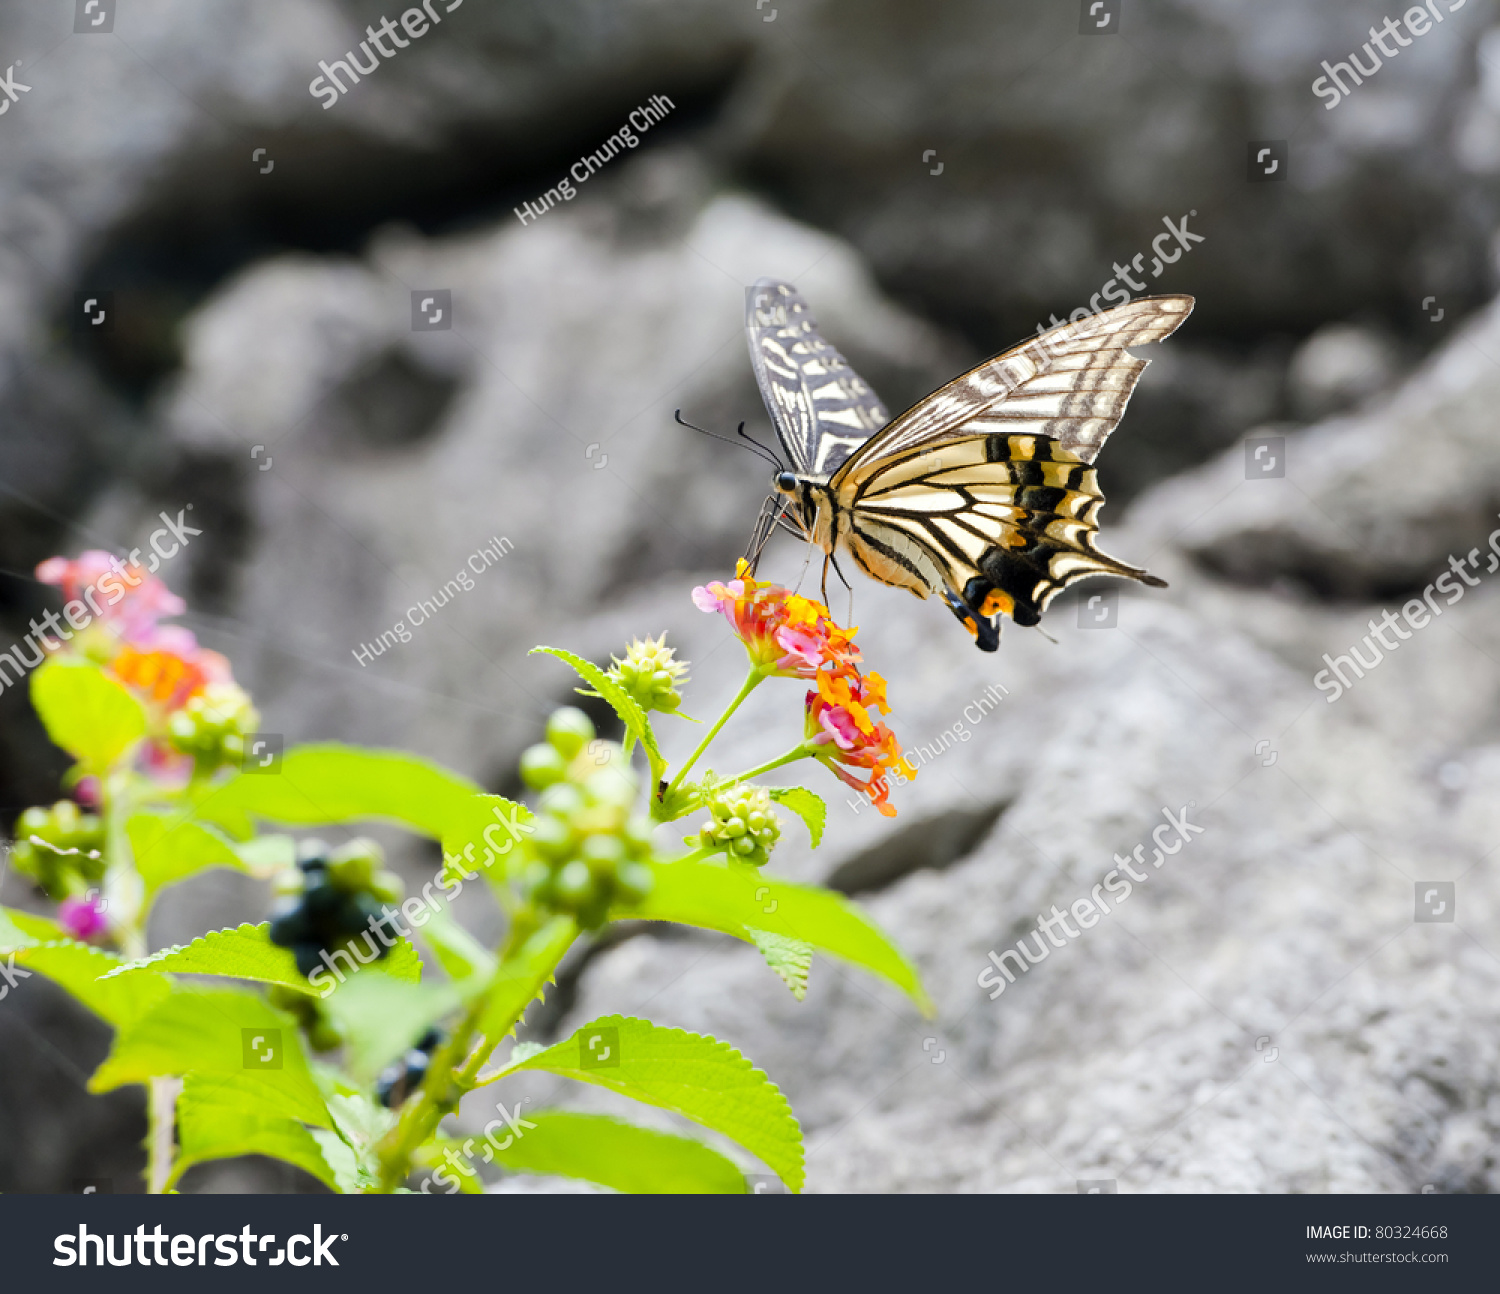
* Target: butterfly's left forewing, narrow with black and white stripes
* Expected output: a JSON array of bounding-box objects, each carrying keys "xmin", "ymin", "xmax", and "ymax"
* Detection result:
[{"xmin": 746, "ymin": 279, "xmax": 891, "ymax": 477}]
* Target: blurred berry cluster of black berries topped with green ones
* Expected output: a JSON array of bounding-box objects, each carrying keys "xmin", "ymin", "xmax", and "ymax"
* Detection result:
[{"xmin": 272, "ymin": 838, "xmax": 402, "ymax": 975}]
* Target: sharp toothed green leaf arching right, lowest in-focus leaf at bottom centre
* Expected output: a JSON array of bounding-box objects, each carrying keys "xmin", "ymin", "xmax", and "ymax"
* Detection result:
[{"xmin": 504, "ymin": 1015, "xmax": 804, "ymax": 1191}]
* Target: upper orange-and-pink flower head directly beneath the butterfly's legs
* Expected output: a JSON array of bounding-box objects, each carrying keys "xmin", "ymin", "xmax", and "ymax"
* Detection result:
[{"xmin": 693, "ymin": 558, "xmax": 860, "ymax": 679}]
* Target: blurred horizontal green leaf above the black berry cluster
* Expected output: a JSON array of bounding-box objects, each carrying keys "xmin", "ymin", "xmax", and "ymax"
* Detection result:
[{"xmin": 197, "ymin": 744, "xmax": 479, "ymax": 840}]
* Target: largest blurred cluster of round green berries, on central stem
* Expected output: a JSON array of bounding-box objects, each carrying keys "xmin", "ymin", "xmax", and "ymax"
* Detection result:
[{"xmin": 521, "ymin": 706, "xmax": 653, "ymax": 930}]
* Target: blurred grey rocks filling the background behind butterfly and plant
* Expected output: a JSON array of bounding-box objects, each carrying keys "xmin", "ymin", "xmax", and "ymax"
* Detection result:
[{"xmin": 0, "ymin": 0, "xmax": 1500, "ymax": 1192}]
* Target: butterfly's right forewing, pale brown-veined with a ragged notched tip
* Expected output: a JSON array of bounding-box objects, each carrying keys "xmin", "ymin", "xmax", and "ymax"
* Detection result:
[{"xmin": 833, "ymin": 297, "xmax": 1193, "ymax": 487}]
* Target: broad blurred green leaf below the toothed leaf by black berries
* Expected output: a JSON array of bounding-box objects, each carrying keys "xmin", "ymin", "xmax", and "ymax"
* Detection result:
[{"xmin": 89, "ymin": 976, "xmax": 332, "ymax": 1128}]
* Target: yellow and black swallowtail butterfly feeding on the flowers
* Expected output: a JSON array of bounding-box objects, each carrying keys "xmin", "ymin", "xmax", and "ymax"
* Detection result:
[{"xmin": 746, "ymin": 279, "xmax": 1193, "ymax": 651}]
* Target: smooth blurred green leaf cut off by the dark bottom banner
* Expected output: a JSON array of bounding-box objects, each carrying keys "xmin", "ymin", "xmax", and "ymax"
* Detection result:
[{"xmin": 434, "ymin": 1110, "xmax": 746, "ymax": 1195}]
